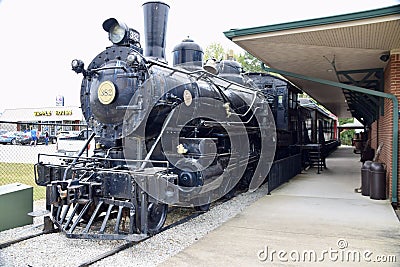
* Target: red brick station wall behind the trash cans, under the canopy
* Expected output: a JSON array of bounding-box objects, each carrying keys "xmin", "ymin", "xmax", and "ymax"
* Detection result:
[{"xmin": 371, "ymin": 51, "xmax": 400, "ymax": 204}]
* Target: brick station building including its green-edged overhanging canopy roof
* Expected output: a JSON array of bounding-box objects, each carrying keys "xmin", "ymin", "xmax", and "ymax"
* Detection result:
[{"xmin": 224, "ymin": 5, "xmax": 400, "ymax": 207}]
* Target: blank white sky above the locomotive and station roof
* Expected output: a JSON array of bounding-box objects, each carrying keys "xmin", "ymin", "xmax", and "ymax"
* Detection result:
[{"xmin": 0, "ymin": 0, "xmax": 400, "ymax": 112}]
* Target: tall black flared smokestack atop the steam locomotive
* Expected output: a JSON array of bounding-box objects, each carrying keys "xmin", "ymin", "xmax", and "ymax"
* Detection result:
[{"xmin": 143, "ymin": 2, "xmax": 169, "ymax": 61}]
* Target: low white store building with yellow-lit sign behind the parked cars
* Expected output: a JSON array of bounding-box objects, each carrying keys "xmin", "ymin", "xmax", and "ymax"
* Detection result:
[{"xmin": 0, "ymin": 106, "xmax": 86, "ymax": 135}]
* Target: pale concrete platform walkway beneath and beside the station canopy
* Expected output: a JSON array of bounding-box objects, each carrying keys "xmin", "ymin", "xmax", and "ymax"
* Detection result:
[{"xmin": 160, "ymin": 147, "xmax": 400, "ymax": 267}]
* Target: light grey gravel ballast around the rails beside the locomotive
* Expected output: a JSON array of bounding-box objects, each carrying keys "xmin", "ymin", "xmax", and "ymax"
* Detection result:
[{"xmin": 0, "ymin": 184, "xmax": 268, "ymax": 267}]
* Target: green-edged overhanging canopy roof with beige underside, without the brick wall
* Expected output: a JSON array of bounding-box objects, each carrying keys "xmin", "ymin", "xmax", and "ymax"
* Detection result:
[{"xmin": 224, "ymin": 5, "xmax": 400, "ymax": 120}]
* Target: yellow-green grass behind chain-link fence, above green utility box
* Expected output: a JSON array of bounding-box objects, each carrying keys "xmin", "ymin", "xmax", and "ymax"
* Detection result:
[{"xmin": 0, "ymin": 162, "xmax": 46, "ymax": 200}]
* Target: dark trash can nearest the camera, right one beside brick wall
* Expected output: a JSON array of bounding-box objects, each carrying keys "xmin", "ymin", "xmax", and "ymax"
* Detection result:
[{"xmin": 369, "ymin": 162, "xmax": 386, "ymax": 199}]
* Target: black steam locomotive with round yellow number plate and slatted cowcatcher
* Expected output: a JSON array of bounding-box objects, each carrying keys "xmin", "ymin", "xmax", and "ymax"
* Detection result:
[{"xmin": 35, "ymin": 2, "xmax": 334, "ymax": 240}]
